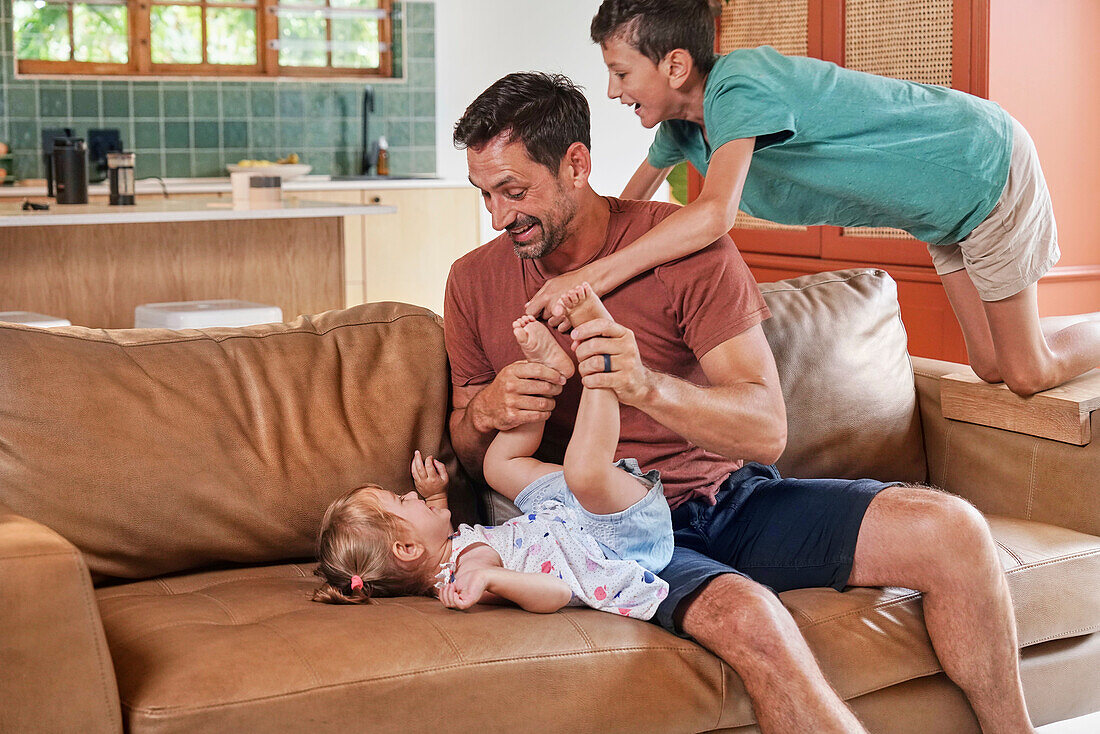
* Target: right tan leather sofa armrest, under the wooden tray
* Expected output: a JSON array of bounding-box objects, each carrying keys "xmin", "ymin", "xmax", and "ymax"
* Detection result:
[{"xmin": 913, "ymin": 357, "xmax": 1100, "ymax": 535}]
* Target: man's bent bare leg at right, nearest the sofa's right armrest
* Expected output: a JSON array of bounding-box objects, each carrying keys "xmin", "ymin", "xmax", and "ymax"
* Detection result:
[{"xmin": 848, "ymin": 486, "xmax": 1034, "ymax": 734}]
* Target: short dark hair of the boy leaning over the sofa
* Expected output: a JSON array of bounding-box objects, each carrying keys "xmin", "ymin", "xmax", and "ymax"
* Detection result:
[{"xmin": 591, "ymin": 0, "xmax": 715, "ymax": 74}]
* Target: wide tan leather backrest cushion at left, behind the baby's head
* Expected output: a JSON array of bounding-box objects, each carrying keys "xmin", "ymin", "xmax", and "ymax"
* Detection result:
[{"xmin": 0, "ymin": 304, "xmax": 455, "ymax": 579}]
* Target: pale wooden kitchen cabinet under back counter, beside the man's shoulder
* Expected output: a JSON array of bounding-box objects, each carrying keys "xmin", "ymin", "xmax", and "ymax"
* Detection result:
[{"xmin": 295, "ymin": 187, "xmax": 481, "ymax": 315}]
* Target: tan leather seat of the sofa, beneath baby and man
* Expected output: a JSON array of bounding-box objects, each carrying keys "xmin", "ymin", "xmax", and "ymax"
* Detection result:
[{"xmin": 97, "ymin": 518, "xmax": 1100, "ymax": 734}]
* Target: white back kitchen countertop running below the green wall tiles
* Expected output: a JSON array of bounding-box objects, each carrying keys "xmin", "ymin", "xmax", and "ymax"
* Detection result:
[{"xmin": 0, "ymin": 171, "xmax": 470, "ymax": 199}]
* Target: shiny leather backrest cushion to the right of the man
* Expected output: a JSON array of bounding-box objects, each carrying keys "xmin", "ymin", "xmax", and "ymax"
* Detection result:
[{"xmin": 760, "ymin": 270, "xmax": 926, "ymax": 482}]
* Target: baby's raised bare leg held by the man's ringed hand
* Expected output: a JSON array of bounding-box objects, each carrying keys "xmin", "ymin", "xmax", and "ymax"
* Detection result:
[{"xmin": 559, "ymin": 283, "xmax": 649, "ymax": 515}]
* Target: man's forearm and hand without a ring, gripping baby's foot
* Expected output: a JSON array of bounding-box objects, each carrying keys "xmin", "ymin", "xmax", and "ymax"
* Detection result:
[{"xmin": 450, "ymin": 361, "xmax": 565, "ymax": 476}]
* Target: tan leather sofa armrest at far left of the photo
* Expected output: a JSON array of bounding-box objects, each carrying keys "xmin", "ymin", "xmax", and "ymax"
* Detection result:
[{"xmin": 0, "ymin": 504, "xmax": 122, "ymax": 734}]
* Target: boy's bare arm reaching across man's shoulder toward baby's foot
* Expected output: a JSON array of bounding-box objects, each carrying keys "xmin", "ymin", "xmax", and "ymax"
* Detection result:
[{"xmin": 525, "ymin": 138, "xmax": 756, "ymax": 321}]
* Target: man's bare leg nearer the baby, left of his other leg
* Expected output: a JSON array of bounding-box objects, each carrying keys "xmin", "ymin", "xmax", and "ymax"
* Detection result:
[{"xmin": 678, "ymin": 573, "xmax": 866, "ymax": 734}]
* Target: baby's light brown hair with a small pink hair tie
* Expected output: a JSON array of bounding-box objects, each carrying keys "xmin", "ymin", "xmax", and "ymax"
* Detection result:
[{"xmin": 314, "ymin": 484, "xmax": 433, "ymax": 604}]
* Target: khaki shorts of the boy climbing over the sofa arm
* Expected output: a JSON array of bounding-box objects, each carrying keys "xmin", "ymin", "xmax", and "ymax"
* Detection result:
[{"xmin": 928, "ymin": 120, "xmax": 1062, "ymax": 300}]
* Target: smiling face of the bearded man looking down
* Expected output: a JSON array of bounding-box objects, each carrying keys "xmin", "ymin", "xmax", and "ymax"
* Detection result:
[{"xmin": 466, "ymin": 134, "xmax": 576, "ymax": 260}]
